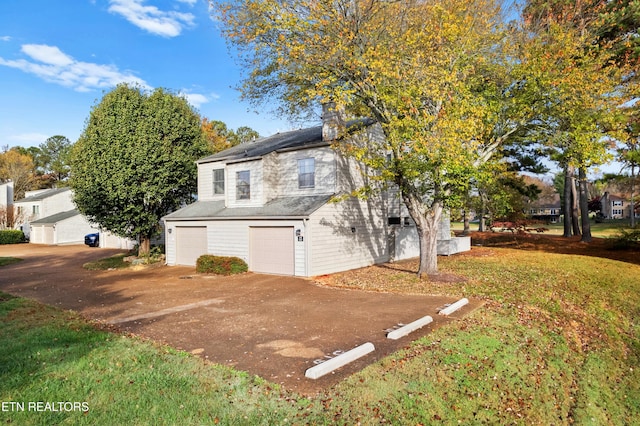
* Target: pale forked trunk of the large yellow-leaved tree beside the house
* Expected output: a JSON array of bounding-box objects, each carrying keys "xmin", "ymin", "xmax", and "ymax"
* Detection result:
[{"xmin": 402, "ymin": 194, "xmax": 442, "ymax": 279}]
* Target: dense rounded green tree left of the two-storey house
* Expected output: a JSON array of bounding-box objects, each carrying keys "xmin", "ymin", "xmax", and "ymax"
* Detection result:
[{"xmin": 71, "ymin": 84, "xmax": 207, "ymax": 255}]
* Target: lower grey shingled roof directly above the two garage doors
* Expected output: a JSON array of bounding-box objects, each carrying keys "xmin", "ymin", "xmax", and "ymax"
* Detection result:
[{"xmin": 163, "ymin": 194, "xmax": 333, "ymax": 220}]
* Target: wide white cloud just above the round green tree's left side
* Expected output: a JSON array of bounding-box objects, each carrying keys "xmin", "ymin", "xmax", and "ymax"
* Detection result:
[{"xmin": 0, "ymin": 44, "xmax": 149, "ymax": 92}]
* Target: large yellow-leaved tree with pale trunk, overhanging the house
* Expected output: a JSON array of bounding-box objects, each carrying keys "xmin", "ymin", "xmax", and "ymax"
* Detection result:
[{"xmin": 212, "ymin": 0, "xmax": 511, "ymax": 275}]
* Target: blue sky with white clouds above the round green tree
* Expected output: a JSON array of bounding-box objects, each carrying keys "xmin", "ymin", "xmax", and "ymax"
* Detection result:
[{"xmin": 0, "ymin": 0, "xmax": 291, "ymax": 147}]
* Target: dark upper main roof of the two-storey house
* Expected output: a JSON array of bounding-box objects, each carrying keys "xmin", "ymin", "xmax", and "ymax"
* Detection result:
[{"xmin": 197, "ymin": 119, "xmax": 374, "ymax": 164}]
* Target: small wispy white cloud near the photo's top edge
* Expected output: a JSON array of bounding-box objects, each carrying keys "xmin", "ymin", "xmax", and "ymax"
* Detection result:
[{"xmin": 109, "ymin": 0, "xmax": 195, "ymax": 37}]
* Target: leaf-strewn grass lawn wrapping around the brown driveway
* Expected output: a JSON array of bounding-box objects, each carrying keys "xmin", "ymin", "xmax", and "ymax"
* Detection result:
[{"xmin": 0, "ymin": 248, "xmax": 640, "ymax": 425}]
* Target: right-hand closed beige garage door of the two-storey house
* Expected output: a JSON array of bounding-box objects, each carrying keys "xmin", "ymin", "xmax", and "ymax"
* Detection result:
[{"xmin": 249, "ymin": 227, "xmax": 295, "ymax": 275}]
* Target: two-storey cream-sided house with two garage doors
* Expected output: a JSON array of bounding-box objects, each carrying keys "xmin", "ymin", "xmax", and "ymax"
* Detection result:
[{"xmin": 164, "ymin": 110, "xmax": 470, "ymax": 276}]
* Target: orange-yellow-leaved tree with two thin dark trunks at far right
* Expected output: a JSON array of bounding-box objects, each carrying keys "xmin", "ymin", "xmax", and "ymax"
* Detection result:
[{"xmin": 520, "ymin": 0, "xmax": 625, "ymax": 242}]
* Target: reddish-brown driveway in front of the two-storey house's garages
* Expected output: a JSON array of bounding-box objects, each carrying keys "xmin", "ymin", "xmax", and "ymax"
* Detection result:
[{"xmin": 0, "ymin": 244, "xmax": 476, "ymax": 394}]
